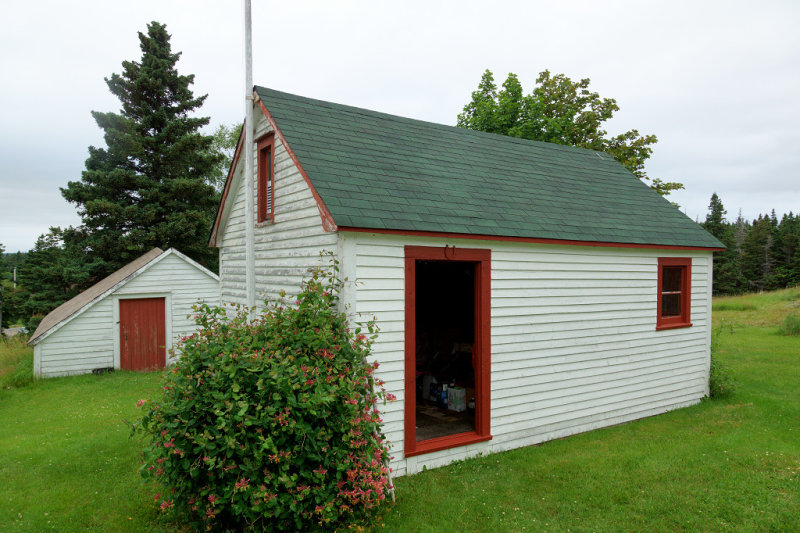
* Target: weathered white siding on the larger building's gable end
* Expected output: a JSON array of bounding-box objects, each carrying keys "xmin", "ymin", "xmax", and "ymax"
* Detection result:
[{"xmin": 220, "ymin": 109, "xmax": 337, "ymax": 305}]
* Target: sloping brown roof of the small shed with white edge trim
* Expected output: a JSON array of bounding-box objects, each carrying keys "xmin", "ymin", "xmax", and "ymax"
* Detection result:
[{"xmin": 28, "ymin": 248, "xmax": 219, "ymax": 344}]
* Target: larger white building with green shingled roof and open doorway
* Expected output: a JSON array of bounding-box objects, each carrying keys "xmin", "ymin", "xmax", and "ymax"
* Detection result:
[{"xmin": 210, "ymin": 87, "xmax": 722, "ymax": 475}]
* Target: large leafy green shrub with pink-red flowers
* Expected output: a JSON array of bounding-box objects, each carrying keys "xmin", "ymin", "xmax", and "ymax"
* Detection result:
[{"xmin": 134, "ymin": 264, "xmax": 391, "ymax": 531}]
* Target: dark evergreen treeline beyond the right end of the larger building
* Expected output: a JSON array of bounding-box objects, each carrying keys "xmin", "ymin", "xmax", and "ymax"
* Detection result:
[{"xmin": 701, "ymin": 193, "xmax": 800, "ymax": 294}]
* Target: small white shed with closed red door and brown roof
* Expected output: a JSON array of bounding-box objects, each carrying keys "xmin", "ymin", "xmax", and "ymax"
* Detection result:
[{"xmin": 29, "ymin": 248, "xmax": 219, "ymax": 377}]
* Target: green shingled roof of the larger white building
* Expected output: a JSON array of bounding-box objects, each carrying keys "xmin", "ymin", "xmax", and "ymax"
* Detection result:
[{"xmin": 256, "ymin": 87, "xmax": 722, "ymax": 247}]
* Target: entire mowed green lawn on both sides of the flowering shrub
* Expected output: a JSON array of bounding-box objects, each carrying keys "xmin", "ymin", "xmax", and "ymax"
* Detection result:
[{"xmin": 0, "ymin": 289, "xmax": 800, "ymax": 532}]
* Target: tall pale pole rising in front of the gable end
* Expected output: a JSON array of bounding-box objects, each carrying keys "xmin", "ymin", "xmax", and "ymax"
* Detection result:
[{"xmin": 244, "ymin": 0, "xmax": 256, "ymax": 308}]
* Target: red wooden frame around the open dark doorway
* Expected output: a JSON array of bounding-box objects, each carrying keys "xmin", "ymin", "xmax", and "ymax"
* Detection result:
[{"xmin": 404, "ymin": 246, "xmax": 492, "ymax": 457}]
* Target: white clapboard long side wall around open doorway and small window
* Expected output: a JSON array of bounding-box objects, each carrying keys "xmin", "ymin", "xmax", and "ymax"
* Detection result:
[{"xmin": 343, "ymin": 233, "xmax": 711, "ymax": 475}]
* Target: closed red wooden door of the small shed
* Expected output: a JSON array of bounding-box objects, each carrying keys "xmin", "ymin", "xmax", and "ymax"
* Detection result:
[{"xmin": 119, "ymin": 298, "xmax": 167, "ymax": 370}]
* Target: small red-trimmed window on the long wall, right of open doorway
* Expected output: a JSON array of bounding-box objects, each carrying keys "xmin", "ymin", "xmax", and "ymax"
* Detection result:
[{"xmin": 656, "ymin": 257, "xmax": 692, "ymax": 329}]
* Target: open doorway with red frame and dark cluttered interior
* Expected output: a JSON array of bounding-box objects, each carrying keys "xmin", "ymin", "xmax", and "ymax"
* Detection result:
[{"xmin": 405, "ymin": 246, "xmax": 492, "ymax": 457}]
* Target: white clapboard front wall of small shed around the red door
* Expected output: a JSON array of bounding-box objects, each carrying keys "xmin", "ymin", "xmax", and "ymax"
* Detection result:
[{"xmin": 34, "ymin": 250, "xmax": 219, "ymax": 377}]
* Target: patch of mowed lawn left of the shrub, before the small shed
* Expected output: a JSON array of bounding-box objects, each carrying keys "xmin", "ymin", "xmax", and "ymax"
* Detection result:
[{"xmin": 0, "ymin": 372, "xmax": 175, "ymax": 531}]
